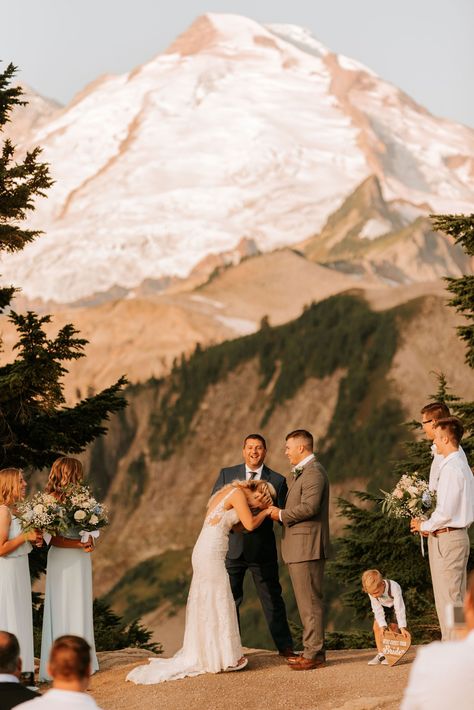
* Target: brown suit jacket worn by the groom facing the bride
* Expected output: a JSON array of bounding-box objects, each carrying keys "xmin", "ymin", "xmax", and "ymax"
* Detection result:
[{"xmin": 281, "ymin": 459, "xmax": 330, "ymax": 564}]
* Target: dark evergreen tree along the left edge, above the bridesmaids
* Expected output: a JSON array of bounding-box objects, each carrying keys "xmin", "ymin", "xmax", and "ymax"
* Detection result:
[{"xmin": 0, "ymin": 64, "xmax": 125, "ymax": 468}]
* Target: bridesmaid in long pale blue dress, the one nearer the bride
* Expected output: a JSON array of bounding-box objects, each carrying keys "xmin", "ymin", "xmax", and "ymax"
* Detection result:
[{"xmin": 40, "ymin": 456, "xmax": 99, "ymax": 681}]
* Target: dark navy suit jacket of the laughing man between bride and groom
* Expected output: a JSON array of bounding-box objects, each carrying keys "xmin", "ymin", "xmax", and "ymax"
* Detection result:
[{"xmin": 212, "ymin": 463, "xmax": 288, "ymax": 562}]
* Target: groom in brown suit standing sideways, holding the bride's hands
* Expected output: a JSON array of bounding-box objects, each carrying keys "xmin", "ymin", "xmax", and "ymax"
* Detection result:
[{"xmin": 271, "ymin": 429, "xmax": 330, "ymax": 671}]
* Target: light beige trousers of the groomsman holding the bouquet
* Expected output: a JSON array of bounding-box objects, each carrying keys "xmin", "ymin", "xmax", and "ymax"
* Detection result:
[{"xmin": 428, "ymin": 528, "xmax": 469, "ymax": 641}]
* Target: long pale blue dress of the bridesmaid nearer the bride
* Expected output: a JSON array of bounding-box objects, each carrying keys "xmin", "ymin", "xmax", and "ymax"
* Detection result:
[{"xmin": 39, "ymin": 529, "xmax": 99, "ymax": 681}]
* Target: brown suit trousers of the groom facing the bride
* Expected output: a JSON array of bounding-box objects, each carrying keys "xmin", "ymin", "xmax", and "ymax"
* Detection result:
[{"xmin": 288, "ymin": 560, "xmax": 326, "ymax": 660}]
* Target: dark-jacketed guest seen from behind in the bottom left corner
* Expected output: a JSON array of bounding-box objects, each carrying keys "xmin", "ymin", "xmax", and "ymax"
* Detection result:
[{"xmin": 0, "ymin": 631, "xmax": 39, "ymax": 710}]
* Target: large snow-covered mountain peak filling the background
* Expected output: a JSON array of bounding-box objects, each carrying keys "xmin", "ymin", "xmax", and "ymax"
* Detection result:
[{"xmin": 0, "ymin": 14, "xmax": 474, "ymax": 302}]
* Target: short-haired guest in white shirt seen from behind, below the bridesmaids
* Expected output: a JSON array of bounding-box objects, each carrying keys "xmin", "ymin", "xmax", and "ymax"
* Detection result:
[{"xmin": 19, "ymin": 636, "xmax": 100, "ymax": 710}]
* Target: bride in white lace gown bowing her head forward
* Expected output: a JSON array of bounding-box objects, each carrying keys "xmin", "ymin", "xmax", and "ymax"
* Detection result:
[{"xmin": 127, "ymin": 480, "xmax": 275, "ymax": 685}]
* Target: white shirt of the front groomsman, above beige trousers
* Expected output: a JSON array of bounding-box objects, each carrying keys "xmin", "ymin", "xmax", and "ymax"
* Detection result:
[{"xmin": 421, "ymin": 451, "xmax": 474, "ymax": 532}]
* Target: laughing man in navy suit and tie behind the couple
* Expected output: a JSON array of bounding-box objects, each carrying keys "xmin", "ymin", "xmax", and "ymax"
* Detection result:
[{"xmin": 212, "ymin": 434, "xmax": 293, "ymax": 657}]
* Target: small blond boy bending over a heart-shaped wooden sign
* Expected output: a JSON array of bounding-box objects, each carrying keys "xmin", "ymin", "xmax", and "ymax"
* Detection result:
[{"xmin": 362, "ymin": 569, "xmax": 408, "ymax": 666}]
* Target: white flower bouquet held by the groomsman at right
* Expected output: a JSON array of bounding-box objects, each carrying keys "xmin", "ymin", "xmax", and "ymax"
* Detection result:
[{"xmin": 382, "ymin": 471, "xmax": 436, "ymax": 518}]
